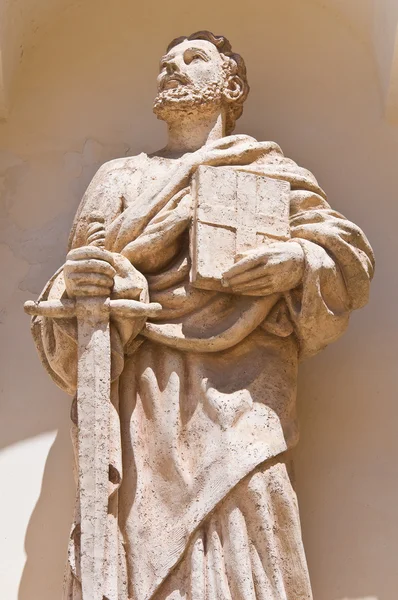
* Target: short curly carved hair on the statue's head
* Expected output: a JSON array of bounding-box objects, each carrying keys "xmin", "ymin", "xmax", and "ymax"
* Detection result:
[{"xmin": 167, "ymin": 31, "xmax": 250, "ymax": 135}]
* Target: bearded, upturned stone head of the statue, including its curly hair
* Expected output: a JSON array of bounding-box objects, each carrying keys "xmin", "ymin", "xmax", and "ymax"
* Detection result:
[{"xmin": 153, "ymin": 31, "xmax": 249, "ymax": 135}]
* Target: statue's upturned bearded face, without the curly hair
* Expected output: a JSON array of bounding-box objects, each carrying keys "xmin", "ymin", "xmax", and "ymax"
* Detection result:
[{"xmin": 154, "ymin": 40, "xmax": 228, "ymax": 121}]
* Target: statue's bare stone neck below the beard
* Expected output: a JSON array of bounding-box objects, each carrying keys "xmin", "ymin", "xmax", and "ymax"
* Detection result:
[{"xmin": 162, "ymin": 109, "xmax": 226, "ymax": 157}]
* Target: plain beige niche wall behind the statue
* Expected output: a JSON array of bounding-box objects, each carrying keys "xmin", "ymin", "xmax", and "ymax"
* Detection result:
[{"xmin": 0, "ymin": 0, "xmax": 398, "ymax": 600}]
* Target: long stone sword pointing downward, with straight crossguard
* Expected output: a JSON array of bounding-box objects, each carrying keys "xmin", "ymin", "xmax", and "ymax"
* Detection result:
[{"xmin": 24, "ymin": 221, "xmax": 162, "ymax": 600}]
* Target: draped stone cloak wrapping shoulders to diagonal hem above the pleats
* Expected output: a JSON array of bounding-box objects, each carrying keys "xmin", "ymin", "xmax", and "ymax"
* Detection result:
[{"xmin": 32, "ymin": 135, "xmax": 373, "ymax": 600}]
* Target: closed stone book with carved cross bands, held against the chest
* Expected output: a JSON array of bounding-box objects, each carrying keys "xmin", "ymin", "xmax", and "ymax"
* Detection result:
[{"xmin": 190, "ymin": 166, "xmax": 290, "ymax": 291}]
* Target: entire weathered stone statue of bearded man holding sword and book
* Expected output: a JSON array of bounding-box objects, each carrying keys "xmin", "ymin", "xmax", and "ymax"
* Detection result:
[{"xmin": 27, "ymin": 31, "xmax": 374, "ymax": 600}]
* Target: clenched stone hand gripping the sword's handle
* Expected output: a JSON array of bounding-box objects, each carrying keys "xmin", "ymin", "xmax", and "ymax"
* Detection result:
[{"xmin": 64, "ymin": 246, "xmax": 116, "ymax": 298}]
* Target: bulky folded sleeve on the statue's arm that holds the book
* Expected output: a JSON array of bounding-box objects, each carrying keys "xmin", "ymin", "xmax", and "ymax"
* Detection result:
[{"xmin": 285, "ymin": 191, "xmax": 374, "ymax": 357}]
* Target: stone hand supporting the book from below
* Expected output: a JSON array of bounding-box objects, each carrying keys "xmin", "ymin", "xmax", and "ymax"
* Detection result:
[{"xmin": 223, "ymin": 241, "xmax": 305, "ymax": 296}]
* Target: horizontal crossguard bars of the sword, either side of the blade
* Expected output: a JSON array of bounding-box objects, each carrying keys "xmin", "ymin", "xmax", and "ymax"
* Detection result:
[{"xmin": 24, "ymin": 298, "xmax": 162, "ymax": 319}]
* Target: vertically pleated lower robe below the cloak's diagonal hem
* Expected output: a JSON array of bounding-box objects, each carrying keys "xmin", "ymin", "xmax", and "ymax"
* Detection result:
[{"xmin": 153, "ymin": 456, "xmax": 312, "ymax": 600}]
